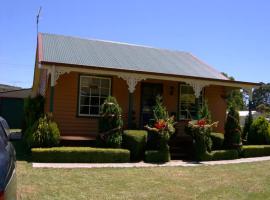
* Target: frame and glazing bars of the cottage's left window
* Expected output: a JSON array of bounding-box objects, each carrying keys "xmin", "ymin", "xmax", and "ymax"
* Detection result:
[{"xmin": 77, "ymin": 74, "xmax": 112, "ymax": 118}]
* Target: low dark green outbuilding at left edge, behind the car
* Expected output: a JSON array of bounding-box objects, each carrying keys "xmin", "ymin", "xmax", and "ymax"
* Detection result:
[{"xmin": 0, "ymin": 89, "xmax": 32, "ymax": 129}]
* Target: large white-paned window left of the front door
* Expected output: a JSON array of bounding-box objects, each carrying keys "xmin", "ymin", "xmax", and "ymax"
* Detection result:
[{"xmin": 79, "ymin": 76, "xmax": 111, "ymax": 116}]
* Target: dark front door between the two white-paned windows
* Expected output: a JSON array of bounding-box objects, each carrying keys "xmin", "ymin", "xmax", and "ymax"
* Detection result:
[{"xmin": 140, "ymin": 83, "xmax": 163, "ymax": 128}]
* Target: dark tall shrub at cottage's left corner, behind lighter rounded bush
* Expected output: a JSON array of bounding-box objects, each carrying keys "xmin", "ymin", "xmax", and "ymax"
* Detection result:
[{"xmin": 22, "ymin": 95, "xmax": 45, "ymax": 132}]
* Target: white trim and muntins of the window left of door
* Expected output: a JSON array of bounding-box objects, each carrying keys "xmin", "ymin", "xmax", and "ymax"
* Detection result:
[{"xmin": 77, "ymin": 75, "xmax": 112, "ymax": 117}]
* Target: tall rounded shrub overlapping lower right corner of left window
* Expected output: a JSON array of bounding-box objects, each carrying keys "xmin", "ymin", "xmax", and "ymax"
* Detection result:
[{"xmin": 97, "ymin": 96, "xmax": 123, "ymax": 148}]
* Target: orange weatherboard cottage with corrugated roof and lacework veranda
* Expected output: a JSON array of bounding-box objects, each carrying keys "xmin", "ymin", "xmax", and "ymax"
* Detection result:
[{"xmin": 32, "ymin": 33, "xmax": 259, "ymax": 142}]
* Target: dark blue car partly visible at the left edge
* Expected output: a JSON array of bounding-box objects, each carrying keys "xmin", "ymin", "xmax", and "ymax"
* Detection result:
[{"xmin": 0, "ymin": 117, "xmax": 17, "ymax": 200}]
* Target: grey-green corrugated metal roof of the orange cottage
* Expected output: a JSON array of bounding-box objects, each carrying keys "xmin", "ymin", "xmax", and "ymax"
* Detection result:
[{"xmin": 39, "ymin": 33, "xmax": 227, "ymax": 80}]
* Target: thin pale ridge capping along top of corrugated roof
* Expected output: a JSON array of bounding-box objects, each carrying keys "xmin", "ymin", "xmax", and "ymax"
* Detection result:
[{"xmin": 40, "ymin": 32, "xmax": 189, "ymax": 53}]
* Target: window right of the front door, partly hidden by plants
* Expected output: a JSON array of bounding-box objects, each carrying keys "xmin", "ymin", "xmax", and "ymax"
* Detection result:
[{"xmin": 179, "ymin": 84, "xmax": 203, "ymax": 119}]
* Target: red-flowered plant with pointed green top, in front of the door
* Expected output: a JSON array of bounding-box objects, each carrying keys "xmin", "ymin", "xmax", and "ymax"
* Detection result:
[{"xmin": 145, "ymin": 96, "xmax": 175, "ymax": 149}]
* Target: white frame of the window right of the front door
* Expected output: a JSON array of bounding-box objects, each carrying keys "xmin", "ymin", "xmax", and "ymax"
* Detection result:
[{"xmin": 178, "ymin": 83, "xmax": 205, "ymax": 121}]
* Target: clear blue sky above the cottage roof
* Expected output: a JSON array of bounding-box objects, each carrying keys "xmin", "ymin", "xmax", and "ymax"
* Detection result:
[{"xmin": 0, "ymin": 0, "xmax": 270, "ymax": 88}]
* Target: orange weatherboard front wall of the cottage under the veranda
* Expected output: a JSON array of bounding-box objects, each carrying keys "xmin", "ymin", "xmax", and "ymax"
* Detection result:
[{"xmin": 45, "ymin": 72, "xmax": 226, "ymax": 136}]
